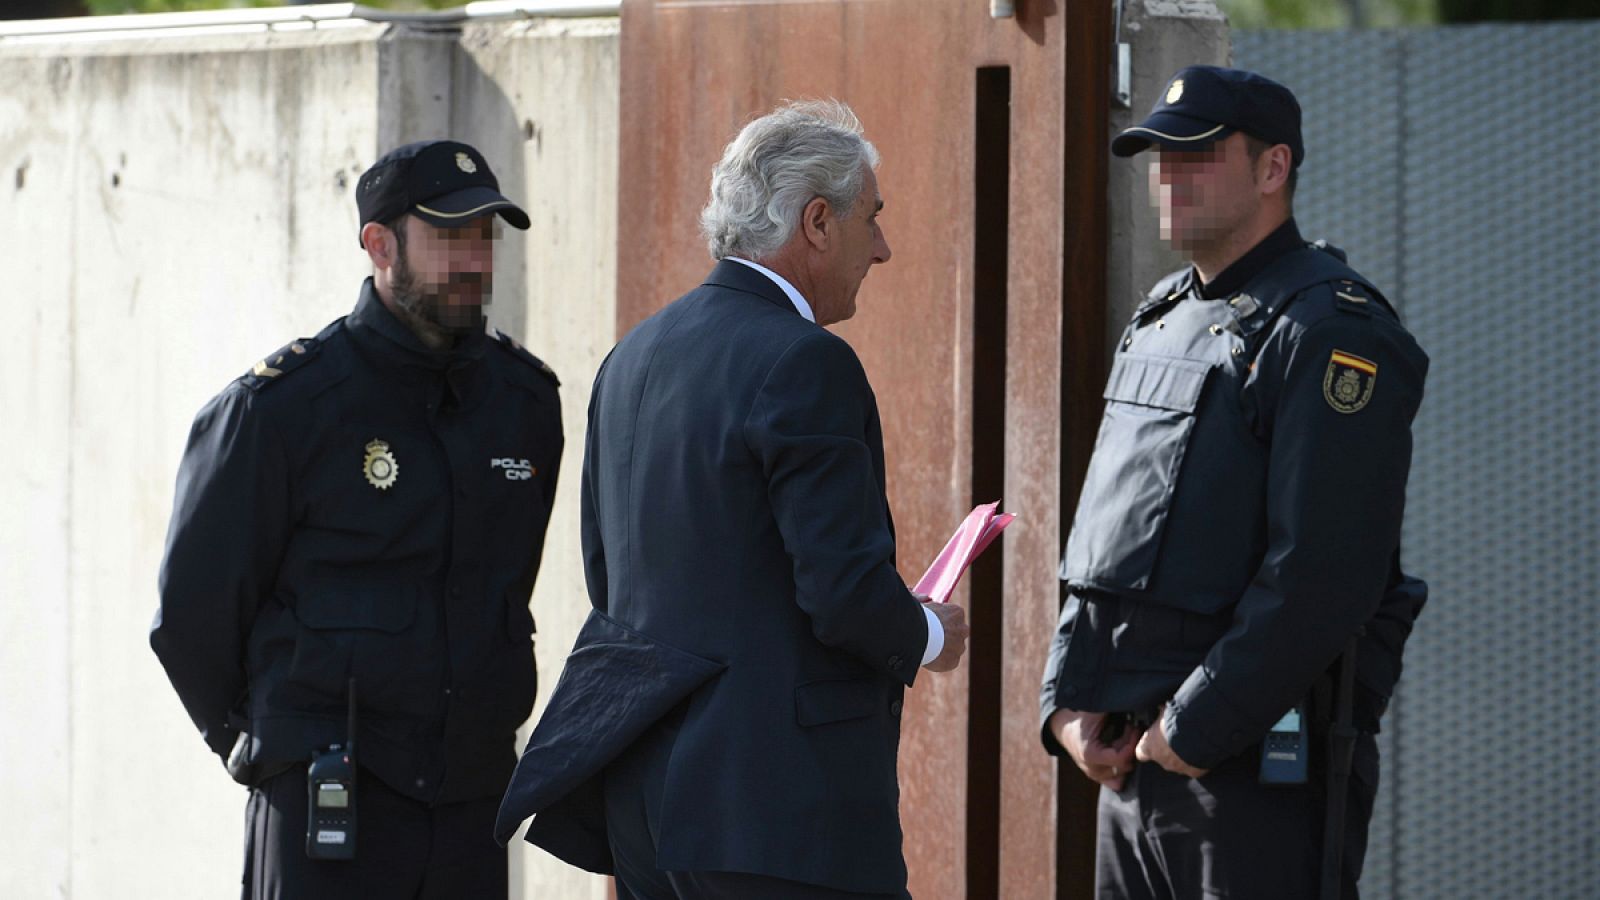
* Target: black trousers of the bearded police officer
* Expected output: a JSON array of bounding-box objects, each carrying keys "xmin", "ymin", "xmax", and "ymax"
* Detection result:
[{"xmin": 243, "ymin": 765, "xmax": 507, "ymax": 900}]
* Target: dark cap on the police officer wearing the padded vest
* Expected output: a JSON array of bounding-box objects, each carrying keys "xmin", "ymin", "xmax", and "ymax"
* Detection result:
[{"xmin": 1110, "ymin": 66, "xmax": 1306, "ymax": 168}]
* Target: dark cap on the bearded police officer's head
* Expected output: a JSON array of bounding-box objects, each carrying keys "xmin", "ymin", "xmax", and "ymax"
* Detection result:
[{"xmin": 355, "ymin": 141, "xmax": 530, "ymax": 245}]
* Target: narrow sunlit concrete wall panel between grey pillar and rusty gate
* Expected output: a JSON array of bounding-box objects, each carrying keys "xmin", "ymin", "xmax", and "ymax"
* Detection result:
[{"xmin": 451, "ymin": 19, "xmax": 621, "ymax": 900}]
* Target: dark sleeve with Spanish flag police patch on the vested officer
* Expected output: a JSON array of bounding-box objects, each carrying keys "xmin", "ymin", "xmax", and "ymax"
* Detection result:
[{"xmin": 1166, "ymin": 307, "xmax": 1426, "ymax": 769}]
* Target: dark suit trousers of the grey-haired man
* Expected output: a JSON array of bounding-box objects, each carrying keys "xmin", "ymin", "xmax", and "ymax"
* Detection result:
[{"xmin": 605, "ymin": 709, "xmax": 910, "ymax": 900}]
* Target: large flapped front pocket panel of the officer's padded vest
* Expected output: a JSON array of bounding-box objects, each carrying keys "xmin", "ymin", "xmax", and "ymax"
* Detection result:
[{"xmin": 1059, "ymin": 354, "xmax": 1213, "ymax": 591}]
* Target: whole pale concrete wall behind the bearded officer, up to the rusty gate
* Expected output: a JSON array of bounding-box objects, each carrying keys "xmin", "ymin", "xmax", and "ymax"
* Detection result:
[{"xmin": 0, "ymin": 19, "xmax": 618, "ymax": 898}]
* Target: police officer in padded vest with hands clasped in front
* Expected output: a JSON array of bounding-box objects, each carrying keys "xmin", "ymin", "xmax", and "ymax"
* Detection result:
[{"xmin": 1040, "ymin": 66, "xmax": 1427, "ymax": 900}]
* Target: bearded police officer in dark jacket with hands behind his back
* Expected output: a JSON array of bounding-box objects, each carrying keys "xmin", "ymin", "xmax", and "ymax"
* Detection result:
[{"xmin": 150, "ymin": 141, "xmax": 562, "ymax": 898}]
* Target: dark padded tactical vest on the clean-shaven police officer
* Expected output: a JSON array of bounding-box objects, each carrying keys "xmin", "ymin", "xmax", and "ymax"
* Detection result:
[{"xmin": 1059, "ymin": 245, "xmax": 1394, "ymax": 615}]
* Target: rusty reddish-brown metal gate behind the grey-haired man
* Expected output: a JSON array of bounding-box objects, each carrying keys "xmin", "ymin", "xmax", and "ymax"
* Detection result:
[{"xmin": 618, "ymin": 0, "xmax": 1110, "ymax": 898}]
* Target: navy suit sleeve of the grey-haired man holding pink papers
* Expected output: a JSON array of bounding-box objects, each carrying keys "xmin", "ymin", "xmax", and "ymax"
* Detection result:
[{"xmin": 744, "ymin": 331, "xmax": 928, "ymax": 684}]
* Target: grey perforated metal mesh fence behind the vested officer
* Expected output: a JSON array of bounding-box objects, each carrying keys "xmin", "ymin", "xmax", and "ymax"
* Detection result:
[{"xmin": 1234, "ymin": 22, "xmax": 1600, "ymax": 900}]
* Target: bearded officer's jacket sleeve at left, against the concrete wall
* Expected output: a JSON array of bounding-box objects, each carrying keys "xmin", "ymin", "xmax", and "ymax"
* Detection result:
[{"xmin": 150, "ymin": 383, "xmax": 290, "ymax": 759}]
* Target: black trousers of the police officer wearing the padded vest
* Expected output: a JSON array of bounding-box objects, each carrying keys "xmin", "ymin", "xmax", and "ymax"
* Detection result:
[{"xmin": 1094, "ymin": 733, "xmax": 1378, "ymax": 900}]
